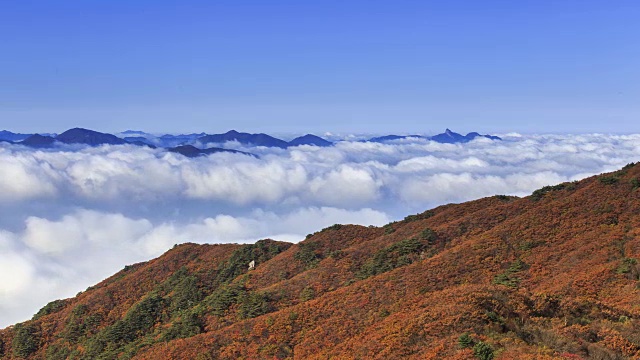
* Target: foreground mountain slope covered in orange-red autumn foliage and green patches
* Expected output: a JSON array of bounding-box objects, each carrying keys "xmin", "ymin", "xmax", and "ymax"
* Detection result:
[{"xmin": 0, "ymin": 165, "xmax": 640, "ymax": 359}]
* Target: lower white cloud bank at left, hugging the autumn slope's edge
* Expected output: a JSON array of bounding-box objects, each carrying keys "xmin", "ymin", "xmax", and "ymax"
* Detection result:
[{"xmin": 0, "ymin": 207, "xmax": 390, "ymax": 326}]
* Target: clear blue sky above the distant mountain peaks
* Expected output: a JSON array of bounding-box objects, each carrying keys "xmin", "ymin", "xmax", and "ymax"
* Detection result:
[{"xmin": 0, "ymin": 0, "xmax": 640, "ymax": 133}]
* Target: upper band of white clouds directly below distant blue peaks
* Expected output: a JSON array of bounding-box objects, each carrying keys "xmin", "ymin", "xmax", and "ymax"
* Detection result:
[{"xmin": 0, "ymin": 135, "xmax": 640, "ymax": 210}]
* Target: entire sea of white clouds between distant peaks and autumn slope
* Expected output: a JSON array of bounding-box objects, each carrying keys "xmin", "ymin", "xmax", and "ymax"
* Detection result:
[{"xmin": 0, "ymin": 134, "xmax": 640, "ymax": 327}]
